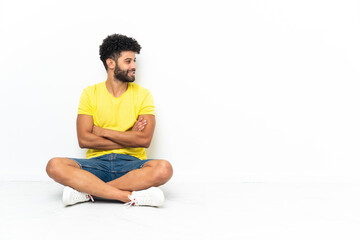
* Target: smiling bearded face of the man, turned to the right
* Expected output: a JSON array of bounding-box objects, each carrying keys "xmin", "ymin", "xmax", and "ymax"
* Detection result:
[{"xmin": 114, "ymin": 51, "xmax": 136, "ymax": 82}]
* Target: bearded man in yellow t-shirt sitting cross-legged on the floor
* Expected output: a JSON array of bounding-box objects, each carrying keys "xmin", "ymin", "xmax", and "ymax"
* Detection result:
[{"xmin": 46, "ymin": 34, "xmax": 172, "ymax": 206}]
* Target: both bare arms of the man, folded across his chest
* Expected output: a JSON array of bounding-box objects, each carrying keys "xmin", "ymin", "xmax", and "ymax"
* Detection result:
[{"xmin": 76, "ymin": 114, "xmax": 155, "ymax": 150}]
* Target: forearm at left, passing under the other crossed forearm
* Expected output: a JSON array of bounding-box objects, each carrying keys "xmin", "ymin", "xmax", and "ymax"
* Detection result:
[{"xmin": 78, "ymin": 133, "xmax": 125, "ymax": 150}]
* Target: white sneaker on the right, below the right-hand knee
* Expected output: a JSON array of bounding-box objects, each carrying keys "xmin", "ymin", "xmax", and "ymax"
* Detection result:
[{"xmin": 125, "ymin": 187, "xmax": 165, "ymax": 207}]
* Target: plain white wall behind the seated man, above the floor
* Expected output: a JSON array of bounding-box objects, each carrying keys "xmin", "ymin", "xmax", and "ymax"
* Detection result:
[{"xmin": 0, "ymin": 0, "xmax": 360, "ymax": 182}]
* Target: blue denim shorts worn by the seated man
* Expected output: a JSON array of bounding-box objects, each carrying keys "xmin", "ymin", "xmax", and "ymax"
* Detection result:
[{"xmin": 70, "ymin": 153, "xmax": 151, "ymax": 182}]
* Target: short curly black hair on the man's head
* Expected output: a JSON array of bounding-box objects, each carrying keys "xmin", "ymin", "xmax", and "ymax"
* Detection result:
[{"xmin": 99, "ymin": 34, "xmax": 141, "ymax": 70}]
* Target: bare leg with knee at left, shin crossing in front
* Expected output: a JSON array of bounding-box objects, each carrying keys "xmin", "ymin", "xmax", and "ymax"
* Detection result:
[{"xmin": 46, "ymin": 158, "xmax": 131, "ymax": 202}]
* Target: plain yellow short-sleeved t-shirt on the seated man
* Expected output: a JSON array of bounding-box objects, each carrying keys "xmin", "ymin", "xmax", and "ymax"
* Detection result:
[{"xmin": 78, "ymin": 82, "xmax": 155, "ymax": 160}]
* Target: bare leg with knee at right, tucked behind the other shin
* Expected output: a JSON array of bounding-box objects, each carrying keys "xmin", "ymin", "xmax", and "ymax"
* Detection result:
[{"xmin": 107, "ymin": 160, "xmax": 173, "ymax": 191}]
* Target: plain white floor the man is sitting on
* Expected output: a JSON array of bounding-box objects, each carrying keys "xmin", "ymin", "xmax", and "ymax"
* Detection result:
[{"xmin": 0, "ymin": 182, "xmax": 360, "ymax": 240}]
